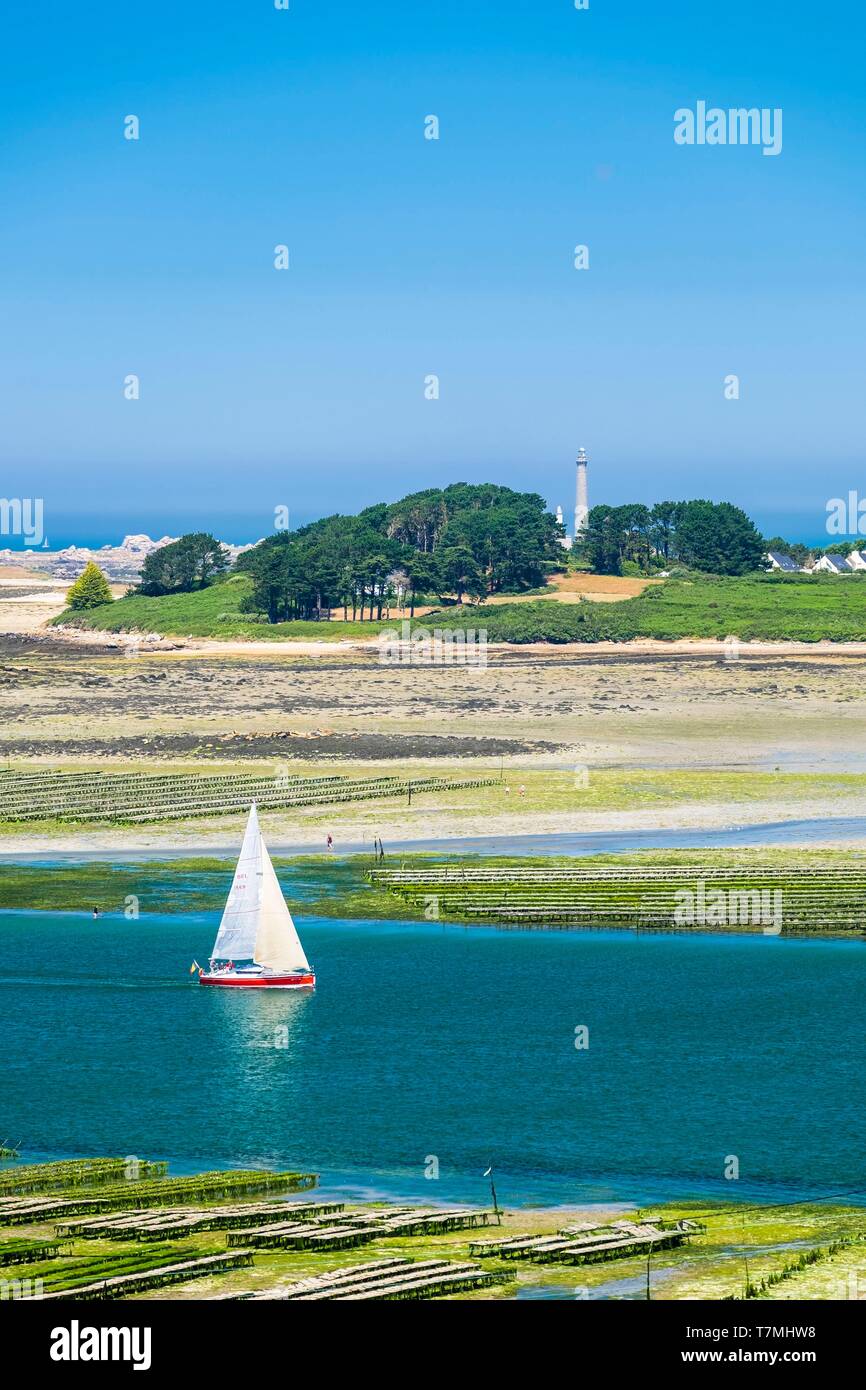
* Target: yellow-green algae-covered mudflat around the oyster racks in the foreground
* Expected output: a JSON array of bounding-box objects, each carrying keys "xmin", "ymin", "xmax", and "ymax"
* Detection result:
[{"xmin": 0, "ymin": 1202, "xmax": 866, "ymax": 1301}]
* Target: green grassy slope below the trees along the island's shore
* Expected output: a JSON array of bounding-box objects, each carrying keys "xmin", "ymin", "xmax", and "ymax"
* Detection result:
[{"xmin": 54, "ymin": 574, "xmax": 866, "ymax": 642}]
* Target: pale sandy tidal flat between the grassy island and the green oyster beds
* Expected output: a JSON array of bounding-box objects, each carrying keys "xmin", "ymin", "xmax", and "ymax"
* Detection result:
[{"xmin": 0, "ymin": 625, "xmax": 866, "ymax": 855}]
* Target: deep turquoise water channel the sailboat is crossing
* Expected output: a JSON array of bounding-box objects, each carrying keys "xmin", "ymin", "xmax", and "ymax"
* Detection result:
[{"xmin": 0, "ymin": 913, "xmax": 866, "ymax": 1202}]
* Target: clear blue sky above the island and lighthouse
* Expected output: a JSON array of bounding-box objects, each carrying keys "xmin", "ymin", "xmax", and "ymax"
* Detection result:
[{"xmin": 0, "ymin": 0, "xmax": 866, "ymax": 545}]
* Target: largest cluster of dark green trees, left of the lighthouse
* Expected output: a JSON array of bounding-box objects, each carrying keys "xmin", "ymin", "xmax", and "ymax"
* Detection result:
[{"xmin": 236, "ymin": 482, "xmax": 563, "ymax": 623}]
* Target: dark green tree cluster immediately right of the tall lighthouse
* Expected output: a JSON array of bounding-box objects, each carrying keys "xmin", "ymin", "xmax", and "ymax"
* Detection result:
[{"xmin": 581, "ymin": 499, "xmax": 767, "ymax": 574}]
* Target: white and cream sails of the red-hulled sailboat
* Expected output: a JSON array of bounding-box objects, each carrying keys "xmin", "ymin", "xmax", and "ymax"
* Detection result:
[{"xmin": 211, "ymin": 803, "xmax": 310, "ymax": 972}]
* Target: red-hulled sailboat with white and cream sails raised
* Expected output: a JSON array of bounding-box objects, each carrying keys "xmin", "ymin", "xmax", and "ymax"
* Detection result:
[{"xmin": 199, "ymin": 802, "xmax": 316, "ymax": 990}]
